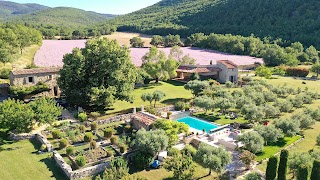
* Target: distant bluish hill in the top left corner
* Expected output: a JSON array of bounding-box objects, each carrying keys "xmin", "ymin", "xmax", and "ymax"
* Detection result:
[{"xmin": 0, "ymin": 1, "xmax": 49, "ymax": 18}]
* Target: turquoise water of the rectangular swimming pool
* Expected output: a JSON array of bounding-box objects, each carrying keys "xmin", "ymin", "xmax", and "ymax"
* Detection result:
[{"xmin": 178, "ymin": 116, "xmax": 219, "ymax": 133}]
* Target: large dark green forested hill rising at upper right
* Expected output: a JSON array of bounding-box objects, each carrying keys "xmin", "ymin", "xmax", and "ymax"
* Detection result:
[{"xmin": 111, "ymin": 0, "xmax": 320, "ymax": 48}]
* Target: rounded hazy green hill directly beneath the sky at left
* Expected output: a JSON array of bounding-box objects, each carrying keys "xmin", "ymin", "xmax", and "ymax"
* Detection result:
[{"xmin": 9, "ymin": 7, "xmax": 111, "ymax": 28}]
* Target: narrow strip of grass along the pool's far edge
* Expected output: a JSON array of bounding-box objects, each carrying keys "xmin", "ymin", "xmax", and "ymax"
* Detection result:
[{"xmin": 194, "ymin": 112, "xmax": 249, "ymax": 125}]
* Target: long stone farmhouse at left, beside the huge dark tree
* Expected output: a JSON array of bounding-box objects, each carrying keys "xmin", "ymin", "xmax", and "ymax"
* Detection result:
[{"xmin": 10, "ymin": 67, "xmax": 61, "ymax": 97}]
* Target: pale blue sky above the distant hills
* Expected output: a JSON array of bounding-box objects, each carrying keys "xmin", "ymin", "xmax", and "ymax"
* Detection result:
[{"xmin": 8, "ymin": 0, "xmax": 160, "ymax": 14}]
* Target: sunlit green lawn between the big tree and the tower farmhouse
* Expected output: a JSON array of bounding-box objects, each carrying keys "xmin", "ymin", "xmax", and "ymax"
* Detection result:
[{"xmin": 99, "ymin": 81, "xmax": 192, "ymax": 119}]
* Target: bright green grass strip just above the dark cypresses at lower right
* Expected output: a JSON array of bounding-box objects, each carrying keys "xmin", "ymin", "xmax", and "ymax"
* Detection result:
[{"xmin": 256, "ymin": 136, "xmax": 301, "ymax": 161}]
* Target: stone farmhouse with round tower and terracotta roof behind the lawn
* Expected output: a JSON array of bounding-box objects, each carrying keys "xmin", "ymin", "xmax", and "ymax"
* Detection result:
[{"xmin": 177, "ymin": 60, "xmax": 239, "ymax": 83}]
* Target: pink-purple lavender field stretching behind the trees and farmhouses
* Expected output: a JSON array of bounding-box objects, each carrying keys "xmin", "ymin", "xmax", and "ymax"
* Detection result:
[{"xmin": 34, "ymin": 40, "xmax": 263, "ymax": 67}]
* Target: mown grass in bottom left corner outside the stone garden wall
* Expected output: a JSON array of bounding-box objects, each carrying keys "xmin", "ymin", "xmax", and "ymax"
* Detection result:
[{"xmin": 0, "ymin": 140, "xmax": 67, "ymax": 180}]
